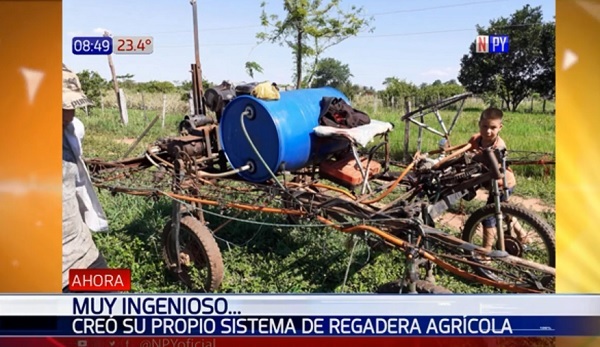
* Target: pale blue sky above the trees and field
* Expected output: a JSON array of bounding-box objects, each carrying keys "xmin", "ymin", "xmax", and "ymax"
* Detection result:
[{"xmin": 62, "ymin": 0, "xmax": 556, "ymax": 90}]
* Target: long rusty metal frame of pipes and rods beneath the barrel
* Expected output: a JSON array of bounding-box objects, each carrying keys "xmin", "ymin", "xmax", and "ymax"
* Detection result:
[{"xmin": 92, "ymin": 132, "xmax": 555, "ymax": 293}]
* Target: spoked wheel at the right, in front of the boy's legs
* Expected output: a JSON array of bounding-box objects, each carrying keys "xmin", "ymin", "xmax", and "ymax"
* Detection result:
[{"xmin": 462, "ymin": 202, "xmax": 556, "ymax": 288}]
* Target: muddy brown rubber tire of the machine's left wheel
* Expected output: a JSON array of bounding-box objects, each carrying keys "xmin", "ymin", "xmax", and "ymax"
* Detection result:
[{"xmin": 162, "ymin": 215, "xmax": 225, "ymax": 292}]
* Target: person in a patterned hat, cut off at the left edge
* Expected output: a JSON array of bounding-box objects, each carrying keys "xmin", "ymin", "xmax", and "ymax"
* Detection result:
[{"xmin": 62, "ymin": 64, "xmax": 108, "ymax": 292}]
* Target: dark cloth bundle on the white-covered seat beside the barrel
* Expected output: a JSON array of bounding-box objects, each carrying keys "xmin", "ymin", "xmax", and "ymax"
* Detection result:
[{"xmin": 319, "ymin": 97, "xmax": 371, "ymax": 128}]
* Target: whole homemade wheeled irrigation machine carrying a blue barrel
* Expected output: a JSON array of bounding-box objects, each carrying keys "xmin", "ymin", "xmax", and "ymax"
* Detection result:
[{"xmin": 83, "ymin": 0, "xmax": 555, "ymax": 293}]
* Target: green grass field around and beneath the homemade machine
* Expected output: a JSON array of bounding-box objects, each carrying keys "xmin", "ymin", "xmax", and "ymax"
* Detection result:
[{"xmin": 78, "ymin": 97, "xmax": 555, "ymax": 293}]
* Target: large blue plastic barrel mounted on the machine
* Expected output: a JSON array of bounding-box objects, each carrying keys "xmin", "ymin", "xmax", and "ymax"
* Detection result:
[{"xmin": 219, "ymin": 87, "xmax": 349, "ymax": 182}]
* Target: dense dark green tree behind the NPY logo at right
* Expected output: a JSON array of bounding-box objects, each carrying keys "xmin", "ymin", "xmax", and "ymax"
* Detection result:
[{"xmin": 458, "ymin": 5, "xmax": 554, "ymax": 111}]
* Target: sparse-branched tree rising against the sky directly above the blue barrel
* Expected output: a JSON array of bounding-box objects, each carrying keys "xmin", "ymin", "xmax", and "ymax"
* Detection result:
[{"xmin": 256, "ymin": 0, "xmax": 372, "ymax": 89}]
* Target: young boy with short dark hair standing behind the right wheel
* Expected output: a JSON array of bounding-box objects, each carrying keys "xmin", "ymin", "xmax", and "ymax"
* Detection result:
[{"xmin": 469, "ymin": 107, "xmax": 526, "ymax": 251}]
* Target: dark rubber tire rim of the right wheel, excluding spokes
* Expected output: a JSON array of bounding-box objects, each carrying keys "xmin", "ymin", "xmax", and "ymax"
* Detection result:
[{"xmin": 462, "ymin": 202, "xmax": 556, "ymax": 280}]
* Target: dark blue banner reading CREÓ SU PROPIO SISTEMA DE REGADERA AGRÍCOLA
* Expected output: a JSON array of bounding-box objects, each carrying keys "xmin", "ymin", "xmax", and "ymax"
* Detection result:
[{"xmin": 0, "ymin": 316, "xmax": 600, "ymax": 336}]
